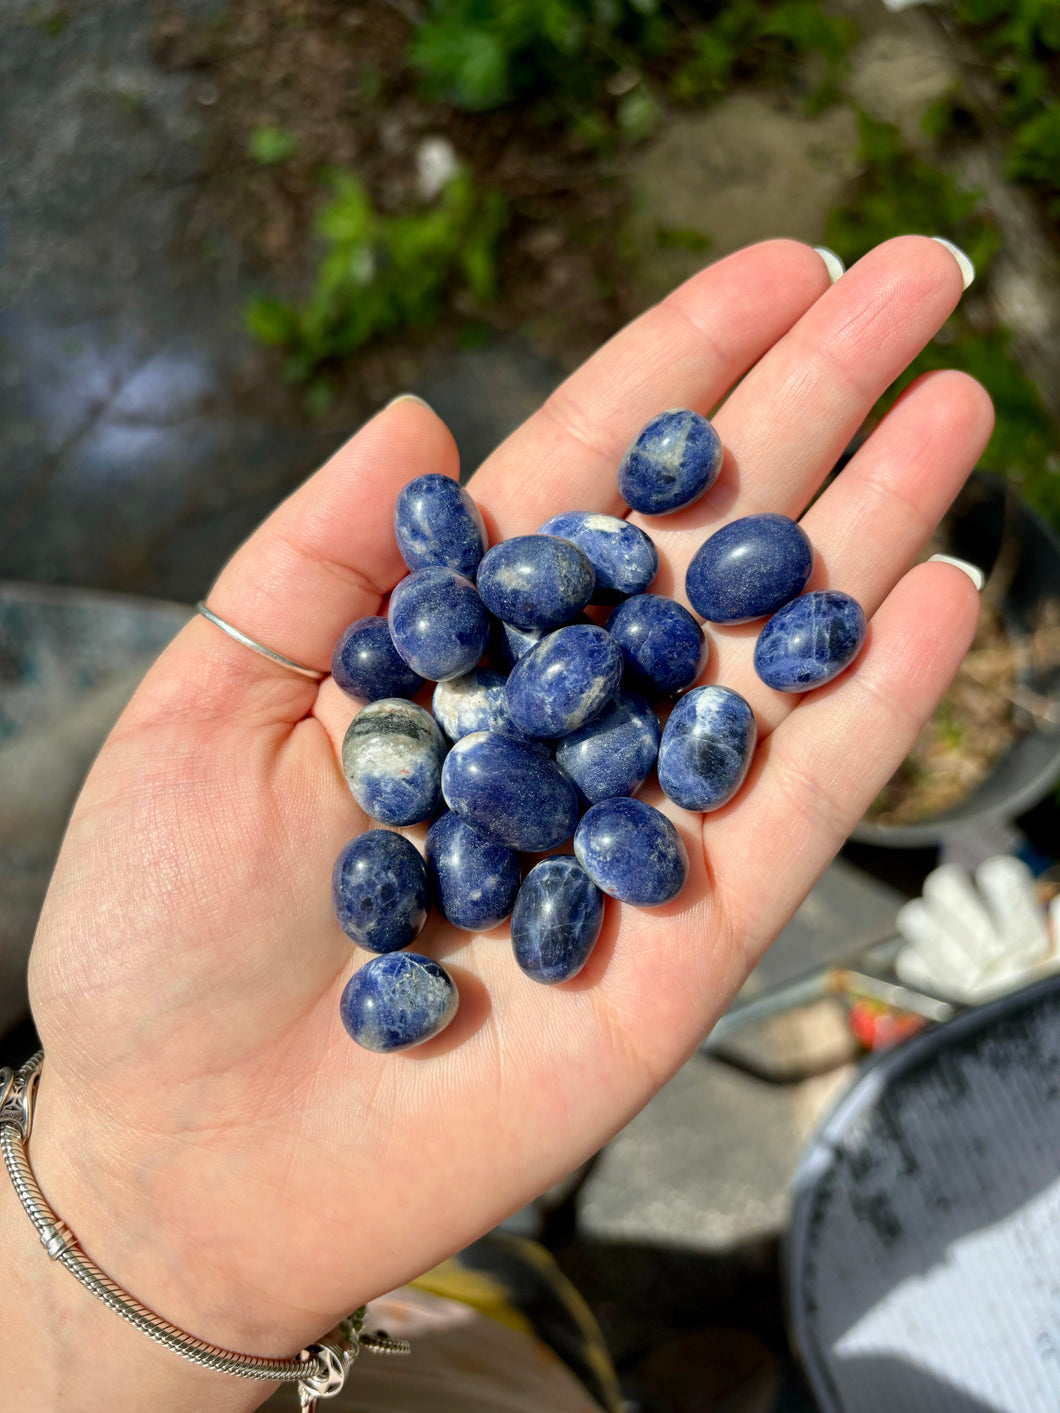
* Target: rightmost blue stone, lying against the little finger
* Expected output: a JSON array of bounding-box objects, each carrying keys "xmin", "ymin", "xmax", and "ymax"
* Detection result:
[{"xmin": 755, "ymin": 589, "xmax": 866, "ymax": 692}]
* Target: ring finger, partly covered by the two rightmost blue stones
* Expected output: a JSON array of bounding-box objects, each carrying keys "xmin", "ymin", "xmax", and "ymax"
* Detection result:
[{"xmin": 705, "ymin": 372, "xmax": 994, "ymax": 735}]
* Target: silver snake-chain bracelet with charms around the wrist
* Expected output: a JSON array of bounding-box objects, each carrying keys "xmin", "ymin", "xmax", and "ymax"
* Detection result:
[{"xmin": 0, "ymin": 1050, "xmax": 408, "ymax": 1413}]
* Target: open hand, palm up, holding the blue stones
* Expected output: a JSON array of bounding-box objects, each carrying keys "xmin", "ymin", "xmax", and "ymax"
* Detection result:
[{"xmin": 6, "ymin": 237, "xmax": 992, "ymax": 1407}]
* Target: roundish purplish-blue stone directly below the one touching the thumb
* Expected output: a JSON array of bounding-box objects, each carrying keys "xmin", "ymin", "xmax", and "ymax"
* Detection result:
[{"xmin": 387, "ymin": 565, "xmax": 489, "ymax": 682}]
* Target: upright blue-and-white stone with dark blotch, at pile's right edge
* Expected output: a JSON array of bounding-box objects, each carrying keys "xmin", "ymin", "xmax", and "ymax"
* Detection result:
[{"xmin": 659, "ymin": 687, "xmax": 758, "ymax": 812}]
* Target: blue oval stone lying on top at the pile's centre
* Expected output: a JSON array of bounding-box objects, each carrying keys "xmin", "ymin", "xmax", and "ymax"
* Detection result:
[{"xmin": 507, "ymin": 623, "xmax": 622, "ymax": 736}]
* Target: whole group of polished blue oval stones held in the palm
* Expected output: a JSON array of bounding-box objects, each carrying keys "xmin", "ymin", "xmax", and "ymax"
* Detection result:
[{"xmin": 332, "ymin": 410, "xmax": 865, "ymax": 1051}]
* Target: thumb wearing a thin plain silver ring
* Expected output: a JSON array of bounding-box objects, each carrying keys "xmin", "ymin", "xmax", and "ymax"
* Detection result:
[{"xmin": 126, "ymin": 400, "xmax": 458, "ymax": 723}]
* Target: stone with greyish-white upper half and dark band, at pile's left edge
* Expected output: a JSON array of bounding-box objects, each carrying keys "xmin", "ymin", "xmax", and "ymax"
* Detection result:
[{"xmin": 342, "ymin": 698, "xmax": 445, "ymax": 824}]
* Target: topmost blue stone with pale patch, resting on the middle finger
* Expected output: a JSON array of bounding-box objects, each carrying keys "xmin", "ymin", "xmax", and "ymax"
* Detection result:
[{"xmin": 619, "ymin": 407, "xmax": 722, "ymax": 516}]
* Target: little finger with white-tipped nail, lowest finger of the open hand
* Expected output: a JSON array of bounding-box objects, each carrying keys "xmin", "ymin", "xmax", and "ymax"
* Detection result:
[{"xmin": 704, "ymin": 564, "xmax": 979, "ymax": 969}]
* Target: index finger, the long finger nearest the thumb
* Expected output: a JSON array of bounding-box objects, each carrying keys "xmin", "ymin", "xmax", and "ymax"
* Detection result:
[{"xmin": 469, "ymin": 240, "xmax": 828, "ymax": 537}]
